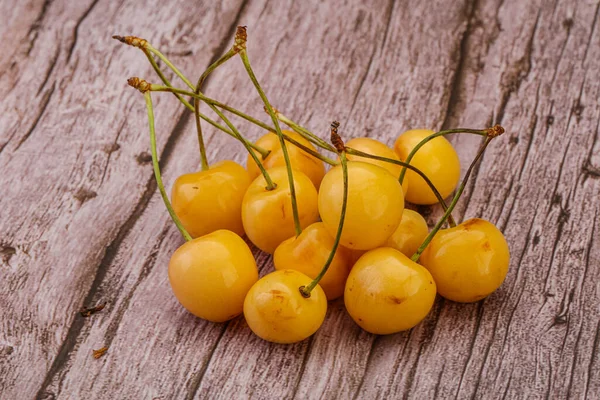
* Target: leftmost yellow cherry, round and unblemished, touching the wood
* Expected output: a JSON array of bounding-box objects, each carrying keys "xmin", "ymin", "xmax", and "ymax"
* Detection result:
[{"xmin": 169, "ymin": 229, "xmax": 258, "ymax": 322}]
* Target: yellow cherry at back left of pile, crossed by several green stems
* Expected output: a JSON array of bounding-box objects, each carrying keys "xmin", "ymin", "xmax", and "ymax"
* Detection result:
[{"xmin": 246, "ymin": 130, "xmax": 325, "ymax": 189}]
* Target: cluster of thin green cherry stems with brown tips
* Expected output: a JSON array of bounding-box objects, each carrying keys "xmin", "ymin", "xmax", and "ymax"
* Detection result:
[{"xmin": 113, "ymin": 27, "xmax": 504, "ymax": 297}]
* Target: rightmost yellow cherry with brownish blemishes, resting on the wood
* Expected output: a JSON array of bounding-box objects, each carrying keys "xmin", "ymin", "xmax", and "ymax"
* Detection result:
[{"xmin": 420, "ymin": 218, "xmax": 510, "ymax": 303}]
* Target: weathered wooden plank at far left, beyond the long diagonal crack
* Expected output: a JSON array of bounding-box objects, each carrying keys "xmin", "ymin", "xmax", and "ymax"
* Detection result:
[{"xmin": 0, "ymin": 1, "xmax": 250, "ymax": 398}]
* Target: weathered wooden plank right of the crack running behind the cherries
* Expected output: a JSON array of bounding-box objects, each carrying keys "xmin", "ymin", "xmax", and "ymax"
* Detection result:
[{"xmin": 358, "ymin": 1, "xmax": 600, "ymax": 398}]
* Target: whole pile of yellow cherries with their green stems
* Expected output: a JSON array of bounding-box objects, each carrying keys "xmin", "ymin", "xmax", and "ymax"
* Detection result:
[{"xmin": 115, "ymin": 27, "xmax": 509, "ymax": 343}]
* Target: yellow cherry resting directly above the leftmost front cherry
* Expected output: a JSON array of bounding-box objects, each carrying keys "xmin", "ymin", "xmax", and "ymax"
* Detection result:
[{"xmin": 171, "ymin": 161, "xmax": 251, "ymax": 237}]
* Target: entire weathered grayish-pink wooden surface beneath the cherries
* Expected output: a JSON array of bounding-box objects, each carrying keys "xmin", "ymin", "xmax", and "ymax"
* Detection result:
[{"xmin": 0, "ymin": 0, "xmax": 600, "ymax": 399}]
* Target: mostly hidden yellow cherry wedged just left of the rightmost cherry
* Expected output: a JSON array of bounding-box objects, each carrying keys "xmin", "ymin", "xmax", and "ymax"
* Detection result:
[{"xmin": 386, "ymin": 208, "xmax": 429, "ymax": 257}]
